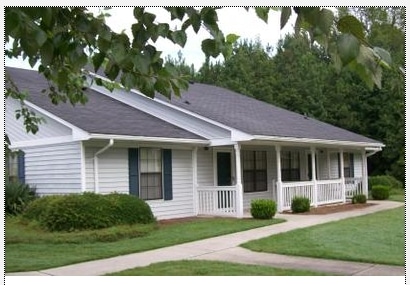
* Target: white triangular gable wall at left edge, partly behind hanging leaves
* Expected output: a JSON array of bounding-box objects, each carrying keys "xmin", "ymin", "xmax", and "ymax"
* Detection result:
[{"xmin": 5, "ymin": 98, "xmax": 71, "ymax": 144}]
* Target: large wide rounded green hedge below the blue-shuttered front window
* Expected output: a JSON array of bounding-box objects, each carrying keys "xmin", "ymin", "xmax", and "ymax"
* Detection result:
[{"xmin": 24, "ymin": 193, "xmax": 155, "ymax": 231}]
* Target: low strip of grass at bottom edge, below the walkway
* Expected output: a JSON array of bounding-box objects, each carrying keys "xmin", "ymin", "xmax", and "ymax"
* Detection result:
[{"xmin": 108, "ymin": 260, "xmax": 326, "ymax": 276}]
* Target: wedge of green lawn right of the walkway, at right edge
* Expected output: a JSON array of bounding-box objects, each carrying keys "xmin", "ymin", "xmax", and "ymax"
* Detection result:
[{"xmin": 242, "ymin": 207, "xmax": 405, "ymax": 265}]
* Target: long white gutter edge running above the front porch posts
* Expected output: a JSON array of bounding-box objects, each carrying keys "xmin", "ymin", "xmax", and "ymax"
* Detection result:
[{"xmin": 254, "ymin": 135, "xmax": 385, "ymax": 150}]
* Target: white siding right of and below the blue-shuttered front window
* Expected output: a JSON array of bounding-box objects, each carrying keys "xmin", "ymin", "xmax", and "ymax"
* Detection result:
[{"xmin": 147, "ymin": 149, "xmax": 194, "ymax": 219}]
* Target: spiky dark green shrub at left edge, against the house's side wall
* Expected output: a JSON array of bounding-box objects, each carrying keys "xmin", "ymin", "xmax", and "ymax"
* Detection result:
[{"xmin": 4, "ymin": 181, "xmax": 36, "ymax": 215}]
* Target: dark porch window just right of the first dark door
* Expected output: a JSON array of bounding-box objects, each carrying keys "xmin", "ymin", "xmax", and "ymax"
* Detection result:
[{"xmin": 242, "ymin": 151, "xmax": 268, "ymax": 192}]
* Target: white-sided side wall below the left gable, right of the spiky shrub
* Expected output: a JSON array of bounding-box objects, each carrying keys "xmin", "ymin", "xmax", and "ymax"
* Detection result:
[{"xmin": 22, "ymin": 142, "xmax": 81, "ymax": 195}]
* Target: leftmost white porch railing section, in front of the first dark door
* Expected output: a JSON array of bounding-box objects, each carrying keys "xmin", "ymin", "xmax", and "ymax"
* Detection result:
[{"xmin": 197, "ymin": 186, "xmax": 237, "ymax": 216}]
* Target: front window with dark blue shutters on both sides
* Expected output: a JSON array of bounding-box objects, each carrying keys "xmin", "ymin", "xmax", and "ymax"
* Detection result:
[{"xmin": 139, "ymin": 148, "xmax": 163, "ymax": 200}]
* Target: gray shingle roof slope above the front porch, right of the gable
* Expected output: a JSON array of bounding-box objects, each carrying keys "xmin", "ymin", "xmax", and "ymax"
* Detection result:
[{"xmin": 157, "ymin": 83, "xmax": 380, "ymax": 143}]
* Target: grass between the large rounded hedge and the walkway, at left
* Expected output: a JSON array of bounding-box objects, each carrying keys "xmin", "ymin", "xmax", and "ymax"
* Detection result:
[{"xmin": 5, "ymin": 215, "xmax": 283, "ymax": 272}]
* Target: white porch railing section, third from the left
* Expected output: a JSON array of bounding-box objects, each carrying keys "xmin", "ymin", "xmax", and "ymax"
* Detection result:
[{"xmin": 317, "ymin": 179, "xmax": 344, "ymax": 205}]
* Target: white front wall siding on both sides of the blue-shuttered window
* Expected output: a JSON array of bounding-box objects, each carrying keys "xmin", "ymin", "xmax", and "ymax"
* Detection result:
[{"xmin": 85, "ymin": 147, "xmax": 194, "ymax": 220}]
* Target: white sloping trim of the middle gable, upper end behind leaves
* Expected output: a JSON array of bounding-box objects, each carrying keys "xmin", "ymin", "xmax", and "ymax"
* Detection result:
[{"xmin": 89, "ymin": 72, "xmax": 253, "ymax": 141}]
